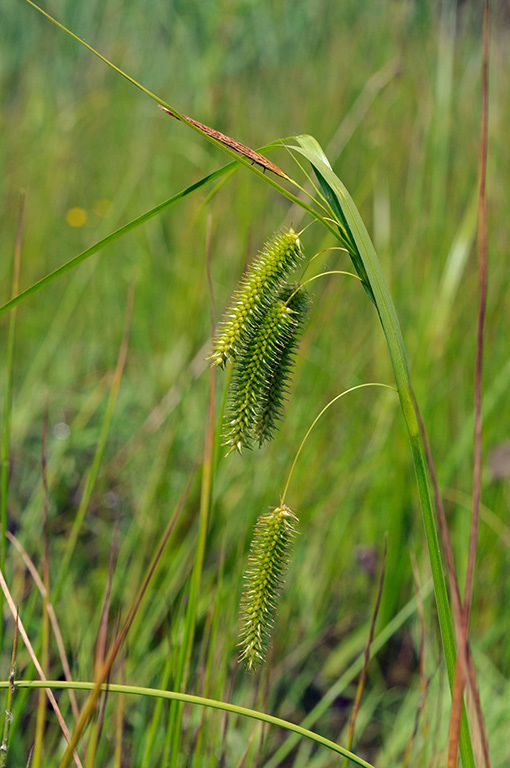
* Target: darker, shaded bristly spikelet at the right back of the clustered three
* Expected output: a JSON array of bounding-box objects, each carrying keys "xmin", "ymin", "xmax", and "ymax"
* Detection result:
[{"xmin": 253, "ymin": 285, "xmax": 311, "ymax": 447}]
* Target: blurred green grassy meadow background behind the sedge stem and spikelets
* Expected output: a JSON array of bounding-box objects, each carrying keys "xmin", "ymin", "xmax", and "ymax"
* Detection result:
[{"xmin": 0, "ymin": 0, "xmax": 510, "ymax": 768}]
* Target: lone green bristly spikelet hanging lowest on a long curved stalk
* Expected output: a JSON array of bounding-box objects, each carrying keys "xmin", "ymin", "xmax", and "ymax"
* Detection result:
[{"xmin": 239, "ymin": 504, "xmax": 297, "ymax": 670}]
